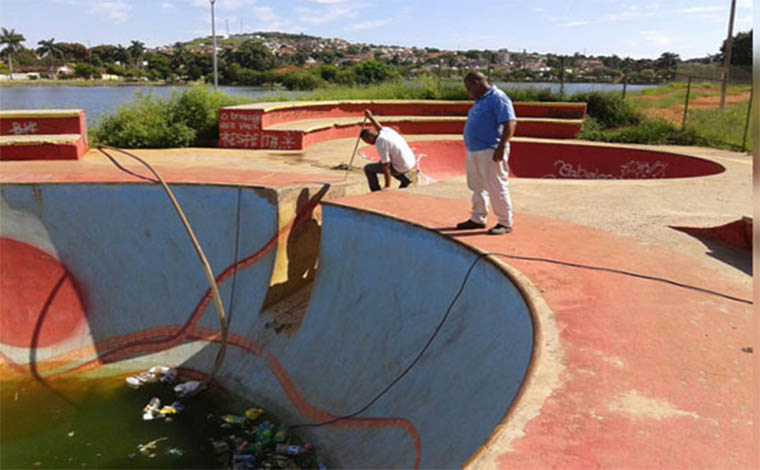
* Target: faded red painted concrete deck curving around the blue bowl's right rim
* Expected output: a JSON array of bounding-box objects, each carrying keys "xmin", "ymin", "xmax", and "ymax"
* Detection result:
[{"xmin": 338, "ymin": 191, "xmax": 754, "ymax": 469}]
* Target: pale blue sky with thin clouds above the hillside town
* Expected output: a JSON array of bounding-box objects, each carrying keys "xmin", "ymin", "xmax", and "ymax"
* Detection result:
[{"xmin": 0, "ymin": 0, "xmax": 753, "ymax": 59}]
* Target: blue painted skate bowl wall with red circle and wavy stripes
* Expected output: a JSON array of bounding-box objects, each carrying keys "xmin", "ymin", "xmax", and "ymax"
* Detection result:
[{"xmin": 0, "ymin": 183, "xmax": 539, "ymax": 468}]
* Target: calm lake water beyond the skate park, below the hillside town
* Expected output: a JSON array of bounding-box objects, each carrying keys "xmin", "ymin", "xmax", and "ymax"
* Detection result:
[{"xmin": 0, "ymin": 82, "xmax": 653, "ymax": 126}]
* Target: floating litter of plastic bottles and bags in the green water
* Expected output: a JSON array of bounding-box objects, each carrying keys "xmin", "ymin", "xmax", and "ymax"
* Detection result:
[{"xmin": 126, "ymin": 366, "xmax": 327, "ymax": 470}]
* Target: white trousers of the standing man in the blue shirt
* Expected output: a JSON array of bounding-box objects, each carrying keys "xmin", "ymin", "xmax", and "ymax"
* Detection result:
[{"xmin": 467, "ymin": 147, "xmax": 512, "ymax": 227}]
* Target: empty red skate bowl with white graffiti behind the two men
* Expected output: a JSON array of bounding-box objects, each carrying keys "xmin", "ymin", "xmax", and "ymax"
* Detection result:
[{"xmin": 360, "ymin": 139, "xmax": 725, "ymax": 184}]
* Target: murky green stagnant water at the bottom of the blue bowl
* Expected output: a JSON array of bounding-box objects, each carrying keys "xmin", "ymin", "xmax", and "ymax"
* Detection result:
[{"xmin": 0, "ymin": 376, "xmax": 317, "ymax": 469}]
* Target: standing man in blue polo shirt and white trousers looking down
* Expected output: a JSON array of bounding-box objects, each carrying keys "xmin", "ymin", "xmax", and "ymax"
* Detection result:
[{"xmin": 457, "ymin": 72, "xmax": 517, "ymax": 235}]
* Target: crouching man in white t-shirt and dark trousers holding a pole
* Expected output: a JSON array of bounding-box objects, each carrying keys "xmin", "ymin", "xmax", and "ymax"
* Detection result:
[{"xmin": 359, "ymin": 109, "xmax": 417, "ymax": 191}]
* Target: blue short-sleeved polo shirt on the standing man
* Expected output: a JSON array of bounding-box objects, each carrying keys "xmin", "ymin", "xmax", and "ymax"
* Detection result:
[{"xmin": 463, "ymin": 85, "xmax": 517, "ymax": 152}]
